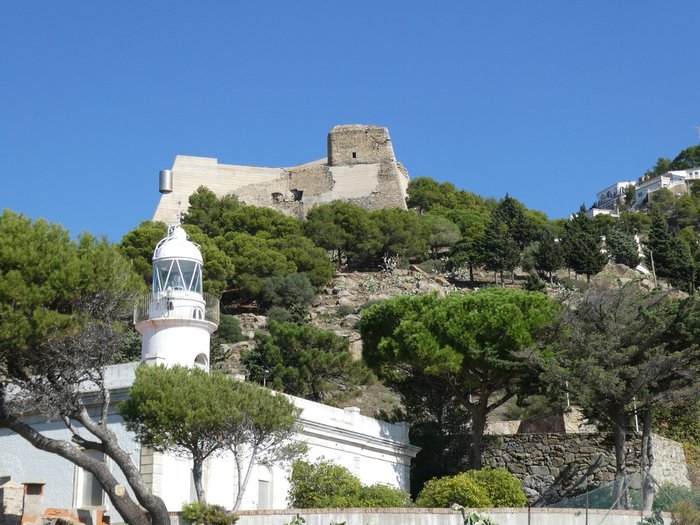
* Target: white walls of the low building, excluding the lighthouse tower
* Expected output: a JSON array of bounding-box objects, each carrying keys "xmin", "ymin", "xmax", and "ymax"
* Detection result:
[{"xmin": 0, "ymin": 363, "xmax": 418, "ymax": 512}]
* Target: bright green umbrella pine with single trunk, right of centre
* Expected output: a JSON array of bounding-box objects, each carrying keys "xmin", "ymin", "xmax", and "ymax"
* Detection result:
[{"xmin": 360, "ymin": 288, "xmax": 556, "ymax": 468}]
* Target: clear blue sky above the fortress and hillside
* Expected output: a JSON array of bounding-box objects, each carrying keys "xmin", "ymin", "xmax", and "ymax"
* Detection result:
[{"xmin": 0, "ymin": 0, "xmax": 700, "ymax": 241}]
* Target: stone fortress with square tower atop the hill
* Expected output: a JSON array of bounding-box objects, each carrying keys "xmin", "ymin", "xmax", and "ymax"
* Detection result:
[{"xmin": 153, "ymin": 124, "xmax": 409, "ymax": 224}]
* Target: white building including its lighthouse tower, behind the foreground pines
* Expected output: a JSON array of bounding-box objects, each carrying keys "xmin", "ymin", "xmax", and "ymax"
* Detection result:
[{"xmin": 0, "ymin": 226, "xmax": 418, "ymax": 521}]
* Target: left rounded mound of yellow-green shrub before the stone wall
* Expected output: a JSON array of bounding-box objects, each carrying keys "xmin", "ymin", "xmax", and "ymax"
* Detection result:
[{"xmin": 416, "ymin": 472, "xmax": 492, "ymax": 508}]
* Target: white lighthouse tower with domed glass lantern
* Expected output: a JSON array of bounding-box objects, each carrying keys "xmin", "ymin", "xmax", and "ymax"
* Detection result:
[{"xmin": 134, "ymin": 224, "xmax": 219, "ymax": 370}]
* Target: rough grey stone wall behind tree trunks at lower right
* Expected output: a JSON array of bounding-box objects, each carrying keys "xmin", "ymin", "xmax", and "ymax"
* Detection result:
[{"xmin": 482, "ymin": 433, "xmax": 690, "ymax": 504}]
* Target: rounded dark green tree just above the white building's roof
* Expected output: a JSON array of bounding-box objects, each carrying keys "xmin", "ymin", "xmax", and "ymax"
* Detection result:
[{"xmin": 241, "ymin": 322, "xmax": 371, "ymax": 404}]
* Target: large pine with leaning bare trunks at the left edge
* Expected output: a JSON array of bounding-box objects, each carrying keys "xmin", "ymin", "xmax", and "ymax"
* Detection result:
[{"xmin": 0, "ymin": 211, "xmax": 170, "ymax": 525}]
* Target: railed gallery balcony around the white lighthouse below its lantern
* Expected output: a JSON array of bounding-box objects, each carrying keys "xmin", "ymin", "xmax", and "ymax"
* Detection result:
[{"xmin": 134, "ymin": 290, "xmax": 219, "ymax": 325}]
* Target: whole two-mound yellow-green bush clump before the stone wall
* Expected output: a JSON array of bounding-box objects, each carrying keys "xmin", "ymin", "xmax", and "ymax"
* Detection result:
[{"xmin": 416, "ymin": 468, "xmax": 527, "ymax": 508}]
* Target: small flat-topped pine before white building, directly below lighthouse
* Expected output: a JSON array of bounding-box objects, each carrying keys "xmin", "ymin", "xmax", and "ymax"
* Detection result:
[{"xmin": 119, "ymin": 366, "xmax": 299, "ymax": 511}]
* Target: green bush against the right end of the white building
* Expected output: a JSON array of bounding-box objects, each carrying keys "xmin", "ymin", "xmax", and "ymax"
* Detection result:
[{"xmin": 289, "ymin": 460, "xmax": 411, "ymax": 509}]
